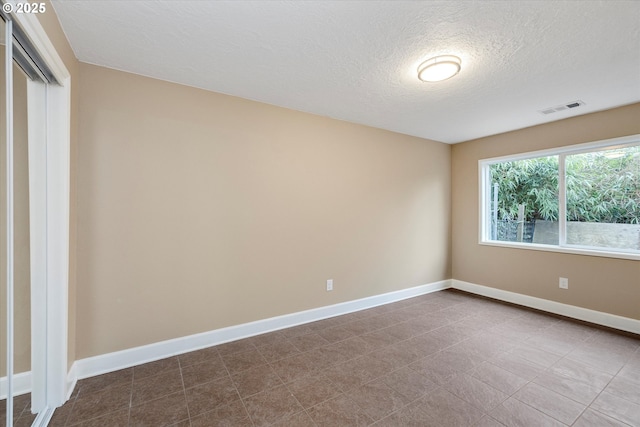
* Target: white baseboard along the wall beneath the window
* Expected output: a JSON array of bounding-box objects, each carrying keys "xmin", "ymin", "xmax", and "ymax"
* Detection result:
[{"xmin": 451, "ymin": 279, "xmax": 640, "ymax": 334}]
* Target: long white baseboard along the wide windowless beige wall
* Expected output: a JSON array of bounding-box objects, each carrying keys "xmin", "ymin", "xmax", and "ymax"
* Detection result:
[{"xmin": 68, "ymin": 280, "xmax": 451, "ymax": 382}]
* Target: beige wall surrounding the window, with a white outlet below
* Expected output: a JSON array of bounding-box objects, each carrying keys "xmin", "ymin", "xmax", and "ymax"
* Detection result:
[{"xmin": 451, "ymin": 104, "xmax": 640, "ymax": 319}]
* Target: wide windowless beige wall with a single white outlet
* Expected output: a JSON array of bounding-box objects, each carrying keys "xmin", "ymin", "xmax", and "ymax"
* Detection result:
[{"xmin": 77, "ymin": 64, "xmax": 451, "ymax": 358}]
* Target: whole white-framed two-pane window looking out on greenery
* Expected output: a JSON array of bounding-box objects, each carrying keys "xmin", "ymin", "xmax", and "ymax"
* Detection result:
[{"xmin": 479, "ymin": 135, "xmax": 640, "ymax": 259}]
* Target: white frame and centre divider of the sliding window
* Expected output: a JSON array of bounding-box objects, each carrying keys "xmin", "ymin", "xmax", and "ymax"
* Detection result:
[{"xmin": 478, "ymin": 134, "xmax": 640, "ymax": 260}]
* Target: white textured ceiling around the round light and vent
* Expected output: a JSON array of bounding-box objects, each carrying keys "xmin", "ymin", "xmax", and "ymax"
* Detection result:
[{"xmin": 53, "ymin": 0, "xmax": 640, "ymax": 143}]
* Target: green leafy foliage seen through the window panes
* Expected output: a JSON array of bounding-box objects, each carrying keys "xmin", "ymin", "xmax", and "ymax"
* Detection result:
[{"xmin": 490, "ymin": 146, "xmax": 640, "ymax": 224}]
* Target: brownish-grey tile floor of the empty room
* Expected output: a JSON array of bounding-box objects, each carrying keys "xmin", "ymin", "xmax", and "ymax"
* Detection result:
[{"xmin": 1, "ymin": 290, "xmax": 640, "ymax": 427}]
